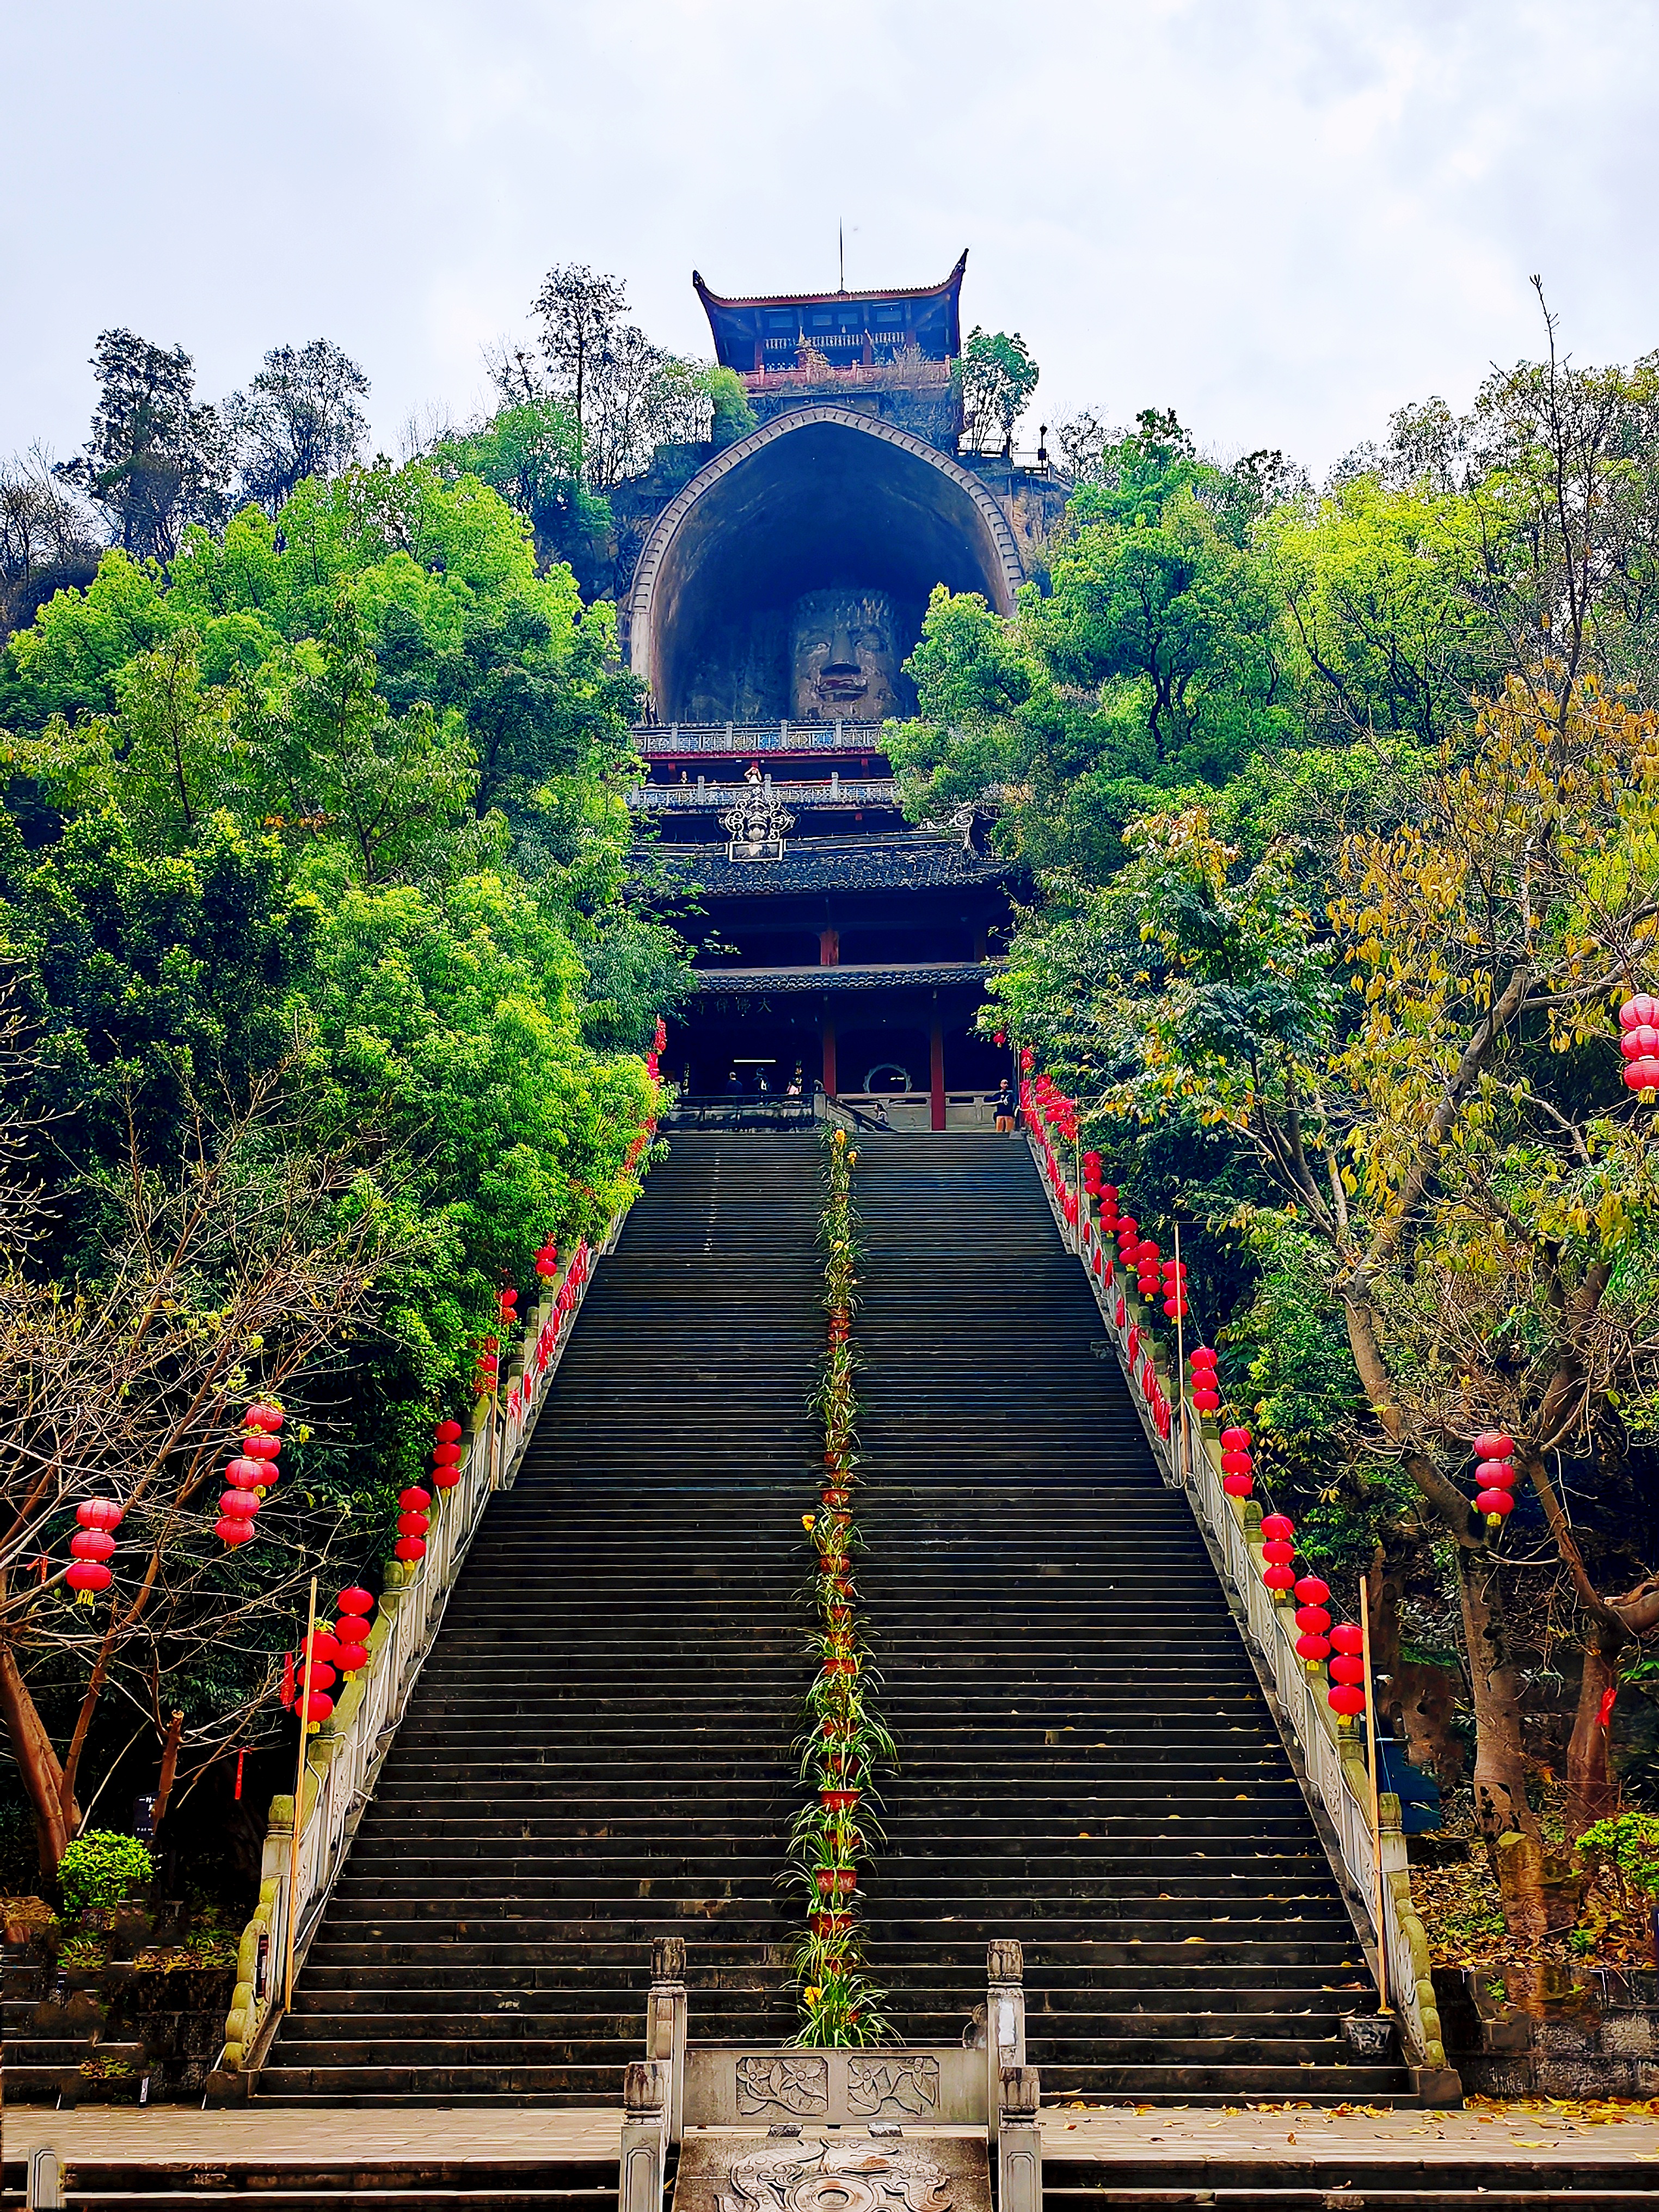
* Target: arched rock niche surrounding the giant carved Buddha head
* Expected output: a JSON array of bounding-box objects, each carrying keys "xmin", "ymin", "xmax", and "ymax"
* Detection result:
[{"xmin": 628, "ymin": 407, "xmax": 1024, "ymax": 721}]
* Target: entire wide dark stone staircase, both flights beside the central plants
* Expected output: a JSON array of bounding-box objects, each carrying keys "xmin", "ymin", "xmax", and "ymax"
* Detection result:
[{"xmin": 261, "ymin": 1135, "xmax": 1409, "ymax": 2106}]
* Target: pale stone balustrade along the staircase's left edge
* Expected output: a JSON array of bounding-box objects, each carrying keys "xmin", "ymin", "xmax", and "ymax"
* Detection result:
[{"xmin": 210, "ymin": 1208, "xmax": 626, "ymax": 2095}]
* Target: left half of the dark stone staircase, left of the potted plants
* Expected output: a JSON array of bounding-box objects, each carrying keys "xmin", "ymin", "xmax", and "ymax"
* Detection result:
[{"xmin": 261, "ymin": 1135, "xmax": 823, "ymax": 2106}]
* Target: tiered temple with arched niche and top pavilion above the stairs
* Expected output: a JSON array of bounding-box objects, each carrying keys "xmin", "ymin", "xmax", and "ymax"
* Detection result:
[{"xmin": 622, "ymin": 254, "xmax": 1068, "ymax": 1128}]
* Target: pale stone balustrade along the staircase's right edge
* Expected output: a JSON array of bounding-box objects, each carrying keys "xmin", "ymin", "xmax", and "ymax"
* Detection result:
[{"xmin": 1031, "ymin": 1141, "xmax": 1455, "ymax": 2102}]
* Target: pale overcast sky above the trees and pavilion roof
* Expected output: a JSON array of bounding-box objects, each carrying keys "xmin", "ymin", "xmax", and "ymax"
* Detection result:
[{"xmin": 0, "ymin": 0, "xmax": 1659, "ymax": 474}]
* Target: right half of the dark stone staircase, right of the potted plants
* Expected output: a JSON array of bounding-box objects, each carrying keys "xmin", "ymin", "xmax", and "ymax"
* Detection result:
[{"xmin": 856, "ymin": 1137, "xmax": 1407, "ymax": 2104}]
